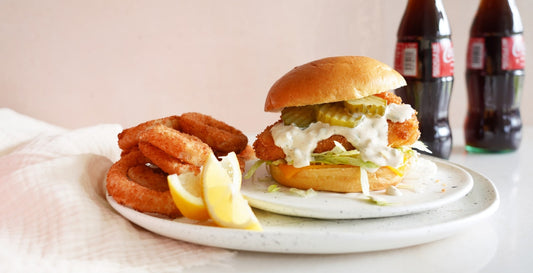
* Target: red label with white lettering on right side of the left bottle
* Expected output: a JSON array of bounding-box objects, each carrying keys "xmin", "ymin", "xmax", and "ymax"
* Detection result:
[{"xmin": 431, "ymin": 39, "xmax": 455, "ymax": 78}]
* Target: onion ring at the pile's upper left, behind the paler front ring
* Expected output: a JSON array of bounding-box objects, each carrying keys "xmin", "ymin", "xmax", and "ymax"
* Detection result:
[{"xmin": 118, "ymin": 116, "xmax": 179, "ymax": 153}]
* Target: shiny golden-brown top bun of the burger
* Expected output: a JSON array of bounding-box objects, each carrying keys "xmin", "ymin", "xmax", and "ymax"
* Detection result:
[{"xmin": 265, "ymin": 56, "xmax": 406, "ymax": 112}]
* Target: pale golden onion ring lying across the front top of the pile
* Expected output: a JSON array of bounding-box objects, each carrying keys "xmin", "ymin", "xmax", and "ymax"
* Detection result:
[{"xmin": 139, "ymin": 125, "xmax": 211, "ymax": 167}]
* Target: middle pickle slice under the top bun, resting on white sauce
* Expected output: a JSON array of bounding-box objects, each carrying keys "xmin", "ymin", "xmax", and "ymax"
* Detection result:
[{"xmin": 316, "ymin": 102, "xmax": 361, "ymax": 128}]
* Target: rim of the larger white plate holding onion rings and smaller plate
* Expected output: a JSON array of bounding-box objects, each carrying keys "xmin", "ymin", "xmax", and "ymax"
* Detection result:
[{"xmin": 104, "ymin": 162, "xmax": 500, "ymax": 254}]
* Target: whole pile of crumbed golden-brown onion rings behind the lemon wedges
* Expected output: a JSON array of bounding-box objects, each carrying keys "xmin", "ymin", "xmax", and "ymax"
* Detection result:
[{"xmin": 106, "ymin": 113, "xmax": 255, "ymax": 218}]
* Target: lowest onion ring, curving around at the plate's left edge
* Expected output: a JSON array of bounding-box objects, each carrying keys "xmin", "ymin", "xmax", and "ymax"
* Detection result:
[{"xmin": 106, "ymin": 151, "xmax": 181, "ymax": 218}]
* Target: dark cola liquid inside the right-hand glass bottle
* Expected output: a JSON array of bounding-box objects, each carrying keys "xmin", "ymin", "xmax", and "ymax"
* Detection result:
[{"xmin": 464, "ymin": 37, "xmax": 524, "ymax": 152}]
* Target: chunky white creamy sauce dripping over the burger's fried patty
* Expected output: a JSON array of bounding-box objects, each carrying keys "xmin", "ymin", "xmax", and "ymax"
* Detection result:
[{"xmin": 271, "ymin": 104, "xmax": 414, "ymax": 171}]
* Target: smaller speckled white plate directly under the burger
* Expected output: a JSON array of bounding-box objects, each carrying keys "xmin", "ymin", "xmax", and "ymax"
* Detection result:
[{"xmin": 241, "ymin": 157, "xmax": 473, "ymax": 219}]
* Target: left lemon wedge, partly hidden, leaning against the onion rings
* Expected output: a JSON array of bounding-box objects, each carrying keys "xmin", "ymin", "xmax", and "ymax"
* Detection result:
[{"xmin": 167, "ymin": 173, "xmax": 209, "ymax": 221}]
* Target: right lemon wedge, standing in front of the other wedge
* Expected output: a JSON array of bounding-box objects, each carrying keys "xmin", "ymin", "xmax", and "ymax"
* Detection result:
[{"xmin": 202, "ymin": 153, "xmax": 262, "ymax": 230}]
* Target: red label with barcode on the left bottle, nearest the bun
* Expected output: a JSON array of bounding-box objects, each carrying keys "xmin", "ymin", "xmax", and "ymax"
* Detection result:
[{"xmin": 394, "ymin": 43, "xmax": 418, "ymax": 77}]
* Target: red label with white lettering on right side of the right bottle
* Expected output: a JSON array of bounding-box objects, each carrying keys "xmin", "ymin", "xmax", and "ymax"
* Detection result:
[{"xmin": 502, "ymin": 35, "xmax": 526, "ymax": 70}]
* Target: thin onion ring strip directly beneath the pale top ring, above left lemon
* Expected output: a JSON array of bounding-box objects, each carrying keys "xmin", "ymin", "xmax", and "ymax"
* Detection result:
[{"xmin": 138, "ymin": 141, "xmax": 200, "ymax": 174}]
